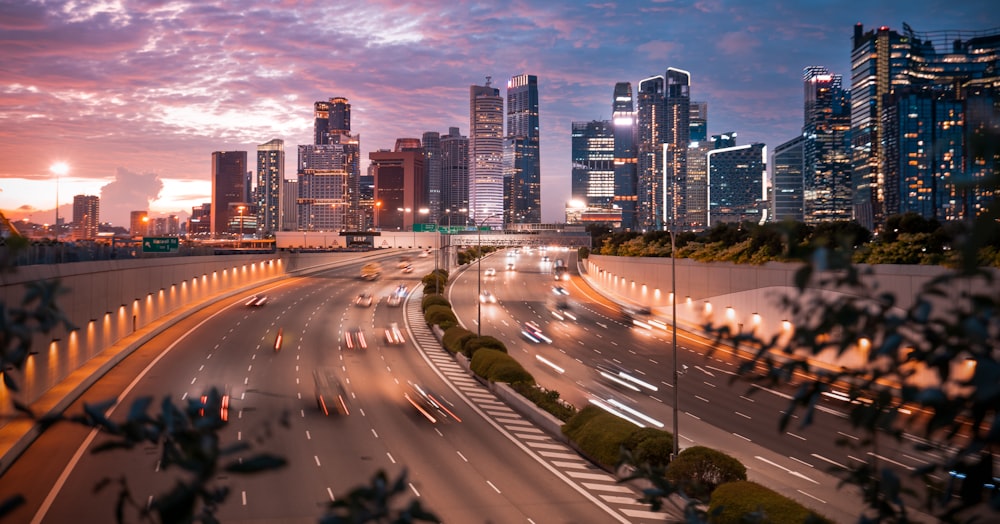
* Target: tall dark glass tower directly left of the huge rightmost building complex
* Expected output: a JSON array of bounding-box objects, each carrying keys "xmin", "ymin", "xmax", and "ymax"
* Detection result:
[{"xmin": 802, "ymin": 66, "xmax": 853, "ymax": 224}]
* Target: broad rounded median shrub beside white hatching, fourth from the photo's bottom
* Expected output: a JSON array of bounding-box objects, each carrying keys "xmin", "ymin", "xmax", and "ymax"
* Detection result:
[{"xmin": 562, "ymin": 406, "xmax": 639, "ymax": 469}]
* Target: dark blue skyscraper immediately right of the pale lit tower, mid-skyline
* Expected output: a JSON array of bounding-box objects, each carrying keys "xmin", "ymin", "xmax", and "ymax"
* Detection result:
[{"xmin": 504, "ymin": 74, "xmax": 542, "ymax": 224}]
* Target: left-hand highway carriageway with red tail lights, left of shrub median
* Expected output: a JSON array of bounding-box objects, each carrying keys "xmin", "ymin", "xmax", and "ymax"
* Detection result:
[{"xmin": 0, "ymin": 258, "xmax": 661, "ymax": 522}]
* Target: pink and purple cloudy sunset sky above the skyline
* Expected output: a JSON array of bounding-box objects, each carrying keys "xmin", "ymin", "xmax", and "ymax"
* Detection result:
[{"xmin": 0, "ymin": 0, "xmax": 1000, "ymax": 226}]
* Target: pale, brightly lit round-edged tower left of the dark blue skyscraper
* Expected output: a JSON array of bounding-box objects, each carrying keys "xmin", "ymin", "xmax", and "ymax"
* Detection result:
[{"xmin": 469, "ymin": 77, "xmax": 504, "ymax": 229}]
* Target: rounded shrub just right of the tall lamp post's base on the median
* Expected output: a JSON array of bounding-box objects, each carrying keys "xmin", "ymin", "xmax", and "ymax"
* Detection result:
[{"xmin": 666, "ymin": 446, "xmax": 747, "ymax": 501}]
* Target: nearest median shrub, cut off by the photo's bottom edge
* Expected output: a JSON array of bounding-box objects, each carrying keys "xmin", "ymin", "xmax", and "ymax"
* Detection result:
[{"xmin": 708, "ymin": 480, "xmax": 832, "ymax": 524}]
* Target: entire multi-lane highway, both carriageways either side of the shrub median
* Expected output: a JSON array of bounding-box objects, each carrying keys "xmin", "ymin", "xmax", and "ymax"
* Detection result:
[{"xmin": 0, "ymin": 251, "xmax": 960, "ymax": 522}]
